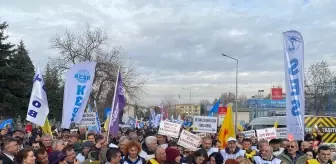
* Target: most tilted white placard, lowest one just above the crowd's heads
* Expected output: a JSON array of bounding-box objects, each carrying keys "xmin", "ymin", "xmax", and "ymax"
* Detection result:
[{"xmin": 177, "ymin": 130, "xmax": 202, "ymax": 151}]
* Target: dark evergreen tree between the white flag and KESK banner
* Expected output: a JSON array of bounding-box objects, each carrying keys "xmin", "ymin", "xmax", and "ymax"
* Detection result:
[{"xmin": 43, "ymin": 64, "xmax": 63, "ymax": 120}]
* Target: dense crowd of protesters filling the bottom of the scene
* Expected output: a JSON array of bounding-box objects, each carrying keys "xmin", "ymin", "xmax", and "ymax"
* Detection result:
[{"xmin": 0, "ymin": 124, "xmax": 336, "ymax": 164}]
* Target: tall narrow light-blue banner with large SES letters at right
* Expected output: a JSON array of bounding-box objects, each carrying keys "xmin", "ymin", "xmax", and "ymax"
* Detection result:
[{"xmin": 283, "ymin": 31, "xmax": 305, "ymax": 140}]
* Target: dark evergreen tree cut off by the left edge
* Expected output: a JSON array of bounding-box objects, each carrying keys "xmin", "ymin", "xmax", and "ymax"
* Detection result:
[{"xmin": 0, "ymin": 22, "xmax": 16, "ymax": 116}]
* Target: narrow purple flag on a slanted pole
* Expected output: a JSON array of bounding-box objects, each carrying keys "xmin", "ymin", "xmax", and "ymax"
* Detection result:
[{"xmin": 109, "ymin": 72, "xmax": 126, "ymax": 137}]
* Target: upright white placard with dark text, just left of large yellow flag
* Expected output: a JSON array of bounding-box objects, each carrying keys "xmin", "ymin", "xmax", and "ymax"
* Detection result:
[{"xmin": 193, "ymin": 116, "xmax": 217, "ymax": 133}]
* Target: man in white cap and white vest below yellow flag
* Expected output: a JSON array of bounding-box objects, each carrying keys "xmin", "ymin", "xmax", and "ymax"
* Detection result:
[{"xmin": 220, "ymin": 137, "xmax": 245, "ymax": 161}]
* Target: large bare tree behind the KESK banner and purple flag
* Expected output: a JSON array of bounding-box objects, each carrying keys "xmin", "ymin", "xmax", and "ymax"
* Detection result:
[{"xmin": 50, "ymin": 23, "xmax": 145, "ymax": 102}]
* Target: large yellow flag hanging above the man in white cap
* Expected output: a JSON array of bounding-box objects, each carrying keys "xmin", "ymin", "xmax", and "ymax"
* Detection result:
[{"xmin": 218, "ymin": 103, "xmax": 236, "ymax": 149}]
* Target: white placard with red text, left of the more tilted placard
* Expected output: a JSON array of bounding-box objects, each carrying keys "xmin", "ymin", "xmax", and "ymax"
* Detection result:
[{"xmin": 158, "ymin": 121, "xmax": 181, "ymax": 138}]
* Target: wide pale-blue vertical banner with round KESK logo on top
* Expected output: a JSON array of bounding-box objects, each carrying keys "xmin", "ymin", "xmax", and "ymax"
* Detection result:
[{"xmin": 61, "ymin": 62, "xmax": 96, "ymax": 128}]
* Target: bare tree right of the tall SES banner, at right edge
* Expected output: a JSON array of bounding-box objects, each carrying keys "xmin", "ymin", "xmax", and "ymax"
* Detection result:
[{"xmin": 304, "ymin": 61, "xmax": 335, "ymax": 114}]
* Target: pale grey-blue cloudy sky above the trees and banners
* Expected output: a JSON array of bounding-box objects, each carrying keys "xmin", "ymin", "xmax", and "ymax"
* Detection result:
[{"xmin": 0, "ymin": 0, "xmax": 336, "ymax": 104}]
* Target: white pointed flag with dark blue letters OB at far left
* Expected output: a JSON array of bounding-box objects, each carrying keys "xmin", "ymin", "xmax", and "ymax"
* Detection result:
[{"xmin": 26, "ymin": 66, "xmax": 49, "ymax": 126}]
